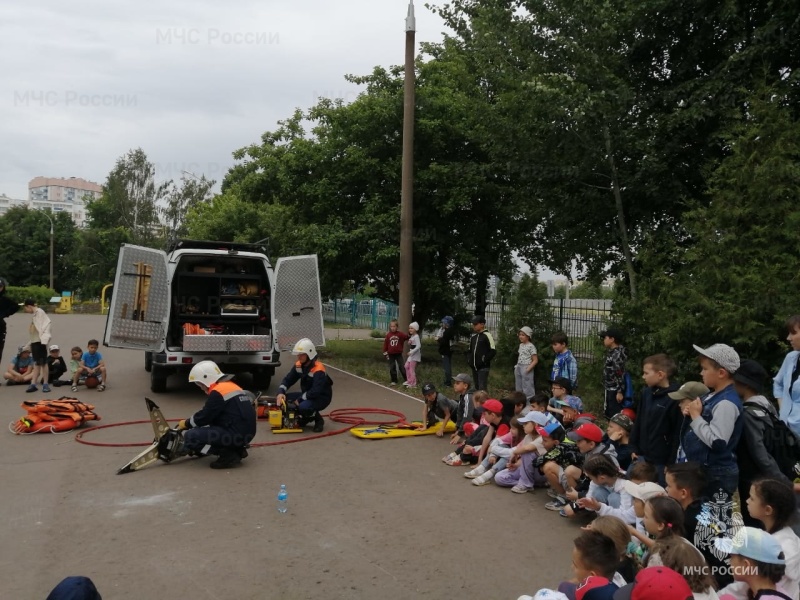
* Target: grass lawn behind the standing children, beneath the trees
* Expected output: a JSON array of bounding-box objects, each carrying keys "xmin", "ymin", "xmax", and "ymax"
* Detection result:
[{"xmin": 320, "ymin": 339, "xmax": 603, "ymax": 416}]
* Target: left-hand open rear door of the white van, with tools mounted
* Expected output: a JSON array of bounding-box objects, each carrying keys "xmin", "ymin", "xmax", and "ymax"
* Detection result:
[{"xmin": 103, "ymin": 244, "xmax": 170, "ymax": 352}]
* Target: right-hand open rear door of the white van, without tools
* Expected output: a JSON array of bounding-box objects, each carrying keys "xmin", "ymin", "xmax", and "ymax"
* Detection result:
[{"xmin": 272, "ymin": 254, "xmax": 325, "ymax": 350}]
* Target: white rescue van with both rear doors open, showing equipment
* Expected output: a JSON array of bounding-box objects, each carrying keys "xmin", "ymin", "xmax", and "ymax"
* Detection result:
[{"xmin": 103, "ymin": 240, "xmax": 325, "ymax": 393}]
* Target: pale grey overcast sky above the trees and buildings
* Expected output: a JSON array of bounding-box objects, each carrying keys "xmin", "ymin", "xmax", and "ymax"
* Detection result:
[{"xmin": 0, "ymin": 0, "xmax": 444, "ymax": 198}]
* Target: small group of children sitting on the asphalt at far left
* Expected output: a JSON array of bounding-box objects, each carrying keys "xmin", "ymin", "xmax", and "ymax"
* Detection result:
[{"xmin": 3, "ymin": 339, "xmax": 108, "ymax": 393}]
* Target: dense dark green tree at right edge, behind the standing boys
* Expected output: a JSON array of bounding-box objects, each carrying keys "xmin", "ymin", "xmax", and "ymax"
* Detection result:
[{"xmin": 615, "ymin": 85, "xmax": 800, "ymax": 373}]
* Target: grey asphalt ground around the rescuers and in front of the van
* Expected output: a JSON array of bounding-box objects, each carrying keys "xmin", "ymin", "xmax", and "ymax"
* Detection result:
[{"xmin": 0, "ymin": 313, "xmax": 579, "ymax": 600}]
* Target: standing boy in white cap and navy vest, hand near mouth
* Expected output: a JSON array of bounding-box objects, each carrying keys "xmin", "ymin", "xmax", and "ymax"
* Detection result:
[{"xmin": 669, "ymin": 344, "xmax": 743, "ymax": 498}]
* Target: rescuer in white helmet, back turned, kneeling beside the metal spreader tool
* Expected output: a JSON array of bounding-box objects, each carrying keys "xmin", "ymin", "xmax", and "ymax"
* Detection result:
[{"xmin": 178, "ymin": 360, "xmax": 256, "ymax": 469}]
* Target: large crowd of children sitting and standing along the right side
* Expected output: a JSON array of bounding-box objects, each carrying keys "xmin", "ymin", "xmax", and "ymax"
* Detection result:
[{"xmin": 412, "ymin": 329, "xmax": 800, "ymax": 600}]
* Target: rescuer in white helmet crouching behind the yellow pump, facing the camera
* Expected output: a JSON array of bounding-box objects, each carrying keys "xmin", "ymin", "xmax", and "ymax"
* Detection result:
[{"xmin": 276, "ymin": 338, "xmax": 333, "ymax": 432}]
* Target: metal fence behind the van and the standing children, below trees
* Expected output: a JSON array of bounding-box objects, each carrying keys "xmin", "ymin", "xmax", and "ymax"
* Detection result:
[{"xmin": 322, "ymin": 298, "xmax": 612, "ymax": 360}]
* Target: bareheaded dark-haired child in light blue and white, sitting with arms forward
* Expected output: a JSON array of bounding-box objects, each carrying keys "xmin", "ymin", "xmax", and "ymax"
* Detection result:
[{"xmin": 562, "ymin": 454, "xmax": 636, "ymax": 525}]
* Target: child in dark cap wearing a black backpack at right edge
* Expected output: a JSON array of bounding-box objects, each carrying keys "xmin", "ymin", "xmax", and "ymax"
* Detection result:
[{"xmin": 733, "ymin": 360, "xmax": 800, "ymax": 527}]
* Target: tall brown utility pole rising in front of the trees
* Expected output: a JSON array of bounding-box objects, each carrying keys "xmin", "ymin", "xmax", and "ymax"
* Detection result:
[{"xmin": 398, "ymin": 0, "xmax": 417, "ymax": 330}]
